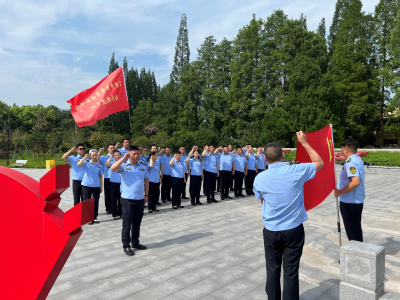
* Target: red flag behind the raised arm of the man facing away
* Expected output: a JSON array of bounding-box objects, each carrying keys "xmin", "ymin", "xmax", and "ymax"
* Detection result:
[{"xmin": 296, "ymin": 125, "xmax": 335, "ymax": 210}]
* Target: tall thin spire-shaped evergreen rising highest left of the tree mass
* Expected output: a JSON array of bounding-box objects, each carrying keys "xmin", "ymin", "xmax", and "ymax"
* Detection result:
[{"xmin": 171, "ymin": 14, "xmax": 190, "ymax": 84}]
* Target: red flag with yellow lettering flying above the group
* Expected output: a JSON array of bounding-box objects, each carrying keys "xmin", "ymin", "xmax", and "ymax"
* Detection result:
[{"xmin": 67, "ymin": 67, "xmax": 129, "ymax": 127}]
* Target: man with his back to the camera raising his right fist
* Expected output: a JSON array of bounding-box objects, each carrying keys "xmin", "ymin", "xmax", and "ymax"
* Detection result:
[{"xmin": 254, "ymin": 131, "xmax": 324, "ymax": 299}]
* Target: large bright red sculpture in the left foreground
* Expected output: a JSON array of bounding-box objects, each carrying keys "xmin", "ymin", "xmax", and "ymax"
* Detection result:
[{"xmin": 0, "ymin": 165, "xmax": 94, "ymax": 299}]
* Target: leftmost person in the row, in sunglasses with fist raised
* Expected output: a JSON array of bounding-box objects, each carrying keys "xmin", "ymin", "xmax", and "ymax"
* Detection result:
[{"xmin": 61, "ymin": 143, "xmax": 89, "ymax": 206}]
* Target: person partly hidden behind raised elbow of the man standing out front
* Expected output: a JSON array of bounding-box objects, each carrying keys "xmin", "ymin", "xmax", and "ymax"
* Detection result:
[{"xmin": 105, "ymin": 149, "xmax": 122, "ymax": 220}]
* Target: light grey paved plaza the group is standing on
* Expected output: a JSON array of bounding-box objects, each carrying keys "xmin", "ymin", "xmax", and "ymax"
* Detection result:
[{"xmin": 16, "ymin": 168, "xmax": 400, "ymax": 300}]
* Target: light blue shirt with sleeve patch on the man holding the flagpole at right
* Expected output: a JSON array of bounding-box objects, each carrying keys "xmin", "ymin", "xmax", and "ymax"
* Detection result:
[{"xmin": 339, "ymin": 154, "xmax": 365, "ymax": 203}]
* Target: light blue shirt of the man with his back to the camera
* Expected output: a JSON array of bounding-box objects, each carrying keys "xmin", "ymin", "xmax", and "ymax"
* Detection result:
[{"xmin": 253, "ymin": 162, "xmax": 316, "ymax": 231}]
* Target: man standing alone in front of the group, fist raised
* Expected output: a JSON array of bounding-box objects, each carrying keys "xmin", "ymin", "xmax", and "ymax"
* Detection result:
[{"xmin": 110, "ymin": 146, "xmax": 149, "ymax": 256}]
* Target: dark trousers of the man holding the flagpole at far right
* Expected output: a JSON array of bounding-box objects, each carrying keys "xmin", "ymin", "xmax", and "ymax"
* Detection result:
[{"xmin": 340, "ymin": 202, "xmax": 364, "ymax": 242}]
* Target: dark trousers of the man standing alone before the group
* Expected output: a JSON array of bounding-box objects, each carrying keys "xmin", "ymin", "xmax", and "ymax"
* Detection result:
[{"xmin": 121, "ymin": 198, "xmax": 144, "ymax": 248}]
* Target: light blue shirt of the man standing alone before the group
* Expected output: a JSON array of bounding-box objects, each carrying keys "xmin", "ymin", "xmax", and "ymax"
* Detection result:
[{"xmin": 119, "ymin": 160, "xmax": 149, "ymax": 200}]
